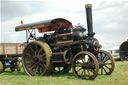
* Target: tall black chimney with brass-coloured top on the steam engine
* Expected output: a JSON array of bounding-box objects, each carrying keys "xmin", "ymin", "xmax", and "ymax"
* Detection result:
[{"xmin": 85, "ymin": 4, "xmax": 95, "ymax": 37}]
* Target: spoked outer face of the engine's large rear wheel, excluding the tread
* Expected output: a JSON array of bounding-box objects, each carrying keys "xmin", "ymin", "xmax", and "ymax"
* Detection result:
[{"xmin": 23, "ymin": 41, "xmax": 49, "ymax": 76}]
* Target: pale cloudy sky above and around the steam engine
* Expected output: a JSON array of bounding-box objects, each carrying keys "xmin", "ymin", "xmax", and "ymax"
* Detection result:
[{"xmin": 0, "ymin": 0, "xmax": 128, "ymax": 49}]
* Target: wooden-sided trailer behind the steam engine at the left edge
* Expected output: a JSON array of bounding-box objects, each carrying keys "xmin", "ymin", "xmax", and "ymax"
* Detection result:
[{"xmin": 0, "ymin": 43, "xmax": 24, "ymax": 72}]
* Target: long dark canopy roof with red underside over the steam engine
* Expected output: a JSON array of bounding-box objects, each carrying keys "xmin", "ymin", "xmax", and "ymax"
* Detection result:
[{"xmin": 15, "ymin": 18, "xmax": 72, "ymax": 33}]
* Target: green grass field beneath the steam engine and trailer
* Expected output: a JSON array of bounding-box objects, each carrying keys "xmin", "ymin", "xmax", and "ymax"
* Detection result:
[{"xmin": 0, "ymin": 61, "xmax": 128, "ymax": 85}]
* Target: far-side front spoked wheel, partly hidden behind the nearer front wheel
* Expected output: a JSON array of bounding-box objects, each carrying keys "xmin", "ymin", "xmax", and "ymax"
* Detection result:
[{"xmin": 98, "ymin": 50, "xmax": 115, "ymax": 75}]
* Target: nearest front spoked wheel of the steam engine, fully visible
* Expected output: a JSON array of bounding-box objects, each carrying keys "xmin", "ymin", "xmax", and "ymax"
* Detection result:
[{"xmin": 72, "ymin": 52, "xmax": 99, "ymax": 80}]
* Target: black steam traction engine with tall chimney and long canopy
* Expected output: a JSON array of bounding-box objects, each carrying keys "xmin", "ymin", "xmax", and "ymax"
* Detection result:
[{"xmin": 15, "ymin": 5, "xmax": 114, "ymax": 80}]
